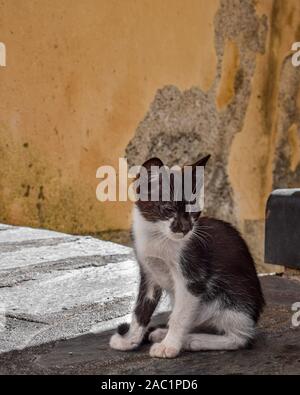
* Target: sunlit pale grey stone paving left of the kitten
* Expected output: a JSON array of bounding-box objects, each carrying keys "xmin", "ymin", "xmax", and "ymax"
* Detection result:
[{"xmin": 0, "ymin": 225, "xmax": 168, "ymax": 352}]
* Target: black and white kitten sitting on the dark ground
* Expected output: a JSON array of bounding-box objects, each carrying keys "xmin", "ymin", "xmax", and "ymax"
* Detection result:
[{"xmin": 110, "ymin": 156, "xmax": 264, "ymax": 358}]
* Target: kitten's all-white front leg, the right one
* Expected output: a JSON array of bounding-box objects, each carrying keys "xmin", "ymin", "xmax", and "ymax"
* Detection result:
[{"xmin": 150, "ymin": 279, "xmax": 199, "ymax": 358}]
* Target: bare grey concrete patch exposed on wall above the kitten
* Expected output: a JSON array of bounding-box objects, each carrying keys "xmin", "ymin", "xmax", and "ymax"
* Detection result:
[{"xmin": 126, "ymin": 0, "xmax": 267, "ymax": 224}]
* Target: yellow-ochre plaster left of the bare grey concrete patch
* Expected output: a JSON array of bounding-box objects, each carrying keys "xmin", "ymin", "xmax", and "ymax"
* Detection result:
[{"xmin": 0, "ymin": 0, "xmax": 218, "ymax": 233}]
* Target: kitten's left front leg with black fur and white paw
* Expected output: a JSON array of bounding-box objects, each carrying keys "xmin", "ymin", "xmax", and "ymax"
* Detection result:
[{"xmin": 109, "ymin": 270, "xmax": 162, "ymax": 351}]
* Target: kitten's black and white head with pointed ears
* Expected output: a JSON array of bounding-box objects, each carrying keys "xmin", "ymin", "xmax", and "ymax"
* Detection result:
[{"xmin": 136, "ymin": 155, "xmax": 210, "ymax": 240}]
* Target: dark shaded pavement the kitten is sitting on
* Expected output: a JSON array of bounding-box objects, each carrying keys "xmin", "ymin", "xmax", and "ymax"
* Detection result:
[{"xmin": 0, "ymin": 276, "xmax": 300, "ymax": 375}]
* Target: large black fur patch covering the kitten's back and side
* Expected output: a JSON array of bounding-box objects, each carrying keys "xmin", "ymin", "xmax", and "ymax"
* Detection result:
[{"xmin": 180, "ymin": 217, "xmax": 264, "ymax": 322}]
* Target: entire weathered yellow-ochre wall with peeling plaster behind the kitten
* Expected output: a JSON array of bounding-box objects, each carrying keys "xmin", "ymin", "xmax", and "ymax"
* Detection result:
[{"xmin": 0, "ymin": 0, "xmax": 300, "ymax": 270}]
